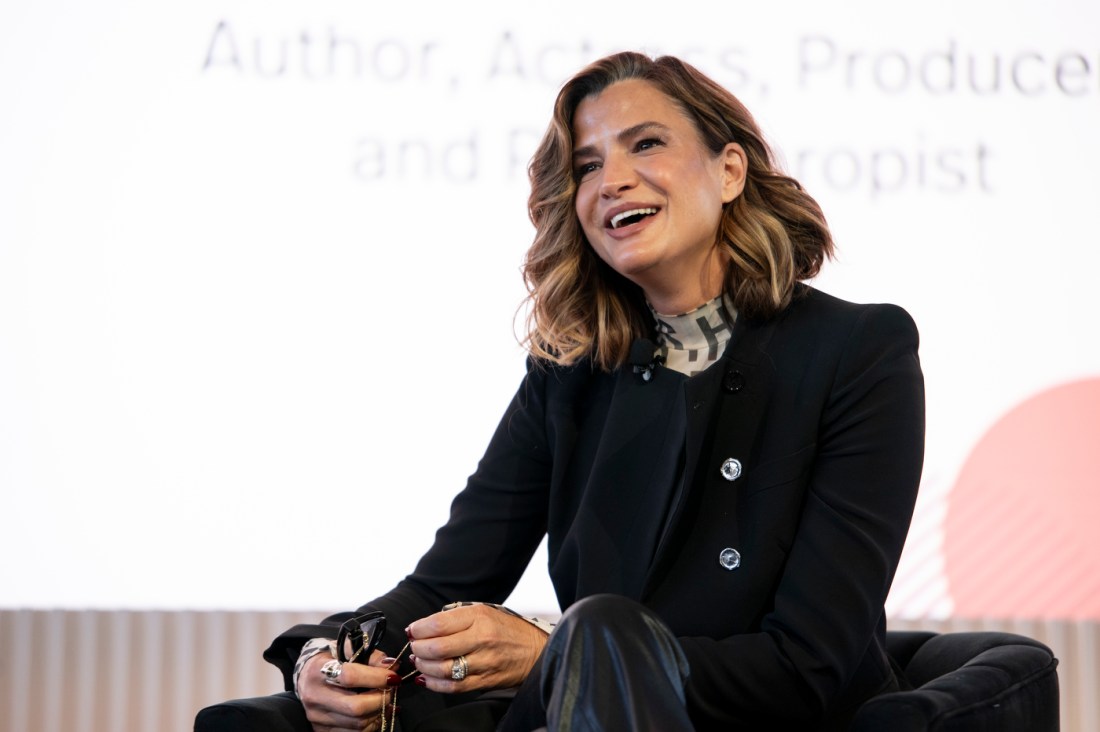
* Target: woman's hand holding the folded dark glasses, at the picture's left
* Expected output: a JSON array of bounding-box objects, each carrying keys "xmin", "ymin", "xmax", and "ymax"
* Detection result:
[{"xmin": 298, "ymin": 651, "xmax": 400, "ymax": 732}]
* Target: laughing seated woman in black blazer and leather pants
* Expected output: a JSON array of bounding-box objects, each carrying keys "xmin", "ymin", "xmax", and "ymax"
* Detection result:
[{"xmin": 255, "ymin": 53, "xmax": 924, "ymax": 730}]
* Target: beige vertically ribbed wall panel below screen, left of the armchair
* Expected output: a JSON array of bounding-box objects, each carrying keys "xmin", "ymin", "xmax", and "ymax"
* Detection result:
[{"xmin": 0, "ymin": 610, "xmax": 325, "ymax": 732}]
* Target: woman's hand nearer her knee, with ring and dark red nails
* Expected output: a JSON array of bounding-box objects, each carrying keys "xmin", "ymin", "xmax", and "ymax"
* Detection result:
[{"xmin": 407, "ymin": 604, "xmax": 547, "ymax": 693}]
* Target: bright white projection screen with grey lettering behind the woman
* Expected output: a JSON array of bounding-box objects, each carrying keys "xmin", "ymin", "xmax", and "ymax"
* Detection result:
[{"xmin": 0, "ymin": 0, "xmax": 1100, "ymax": 615}]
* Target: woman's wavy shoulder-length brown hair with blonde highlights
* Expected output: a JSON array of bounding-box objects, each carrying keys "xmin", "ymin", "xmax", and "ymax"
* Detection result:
[{"xmin": 523, "ymin": 53, "xmax": 833, "ymax": 371}]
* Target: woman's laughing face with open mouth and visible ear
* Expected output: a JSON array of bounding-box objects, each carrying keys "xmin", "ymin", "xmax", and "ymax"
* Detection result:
[{"xmin": 573, "ymin": 79, "xmax": 746, "ymax": 314}]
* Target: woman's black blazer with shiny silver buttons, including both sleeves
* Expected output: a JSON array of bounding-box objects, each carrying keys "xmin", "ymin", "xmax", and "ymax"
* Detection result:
[{"xmin": 265, "ymin": 286, "xmax": 924, "ymax": 729}]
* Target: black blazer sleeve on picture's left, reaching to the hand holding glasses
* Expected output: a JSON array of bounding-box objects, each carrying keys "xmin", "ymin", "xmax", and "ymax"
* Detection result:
[{"xmin": 264, "ymin": 360, "xmax": 552, "ymax": 690}]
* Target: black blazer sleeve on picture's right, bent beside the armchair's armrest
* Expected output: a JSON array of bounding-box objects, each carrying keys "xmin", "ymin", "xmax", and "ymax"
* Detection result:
[{"xmin": 680, "ymin": 305, "xmax": 924, "ymax": 726}]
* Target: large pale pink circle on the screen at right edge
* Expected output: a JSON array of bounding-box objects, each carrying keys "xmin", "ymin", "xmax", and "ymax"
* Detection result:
[{"xmin": 944, "ymin": 379, "xmax": 1100, "ymax": 620}]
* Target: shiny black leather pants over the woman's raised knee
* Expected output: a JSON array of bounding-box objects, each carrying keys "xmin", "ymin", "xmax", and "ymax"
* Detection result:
[{"xmin": 498, "ymin": 594, "xmax": 692, "ymax": 732}]
